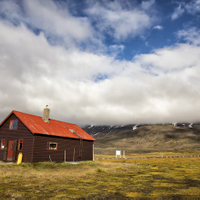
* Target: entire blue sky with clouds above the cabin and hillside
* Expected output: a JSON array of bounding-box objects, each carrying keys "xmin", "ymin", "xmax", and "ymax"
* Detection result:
[{"xmin": 0, "ymin": 0, "xmax": 200, "ymax": 125}]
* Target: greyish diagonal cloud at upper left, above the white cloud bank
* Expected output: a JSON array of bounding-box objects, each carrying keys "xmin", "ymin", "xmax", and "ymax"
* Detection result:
[{"xmin": 0, "ymin": 0, "xmax": 99, "ymax": 48}]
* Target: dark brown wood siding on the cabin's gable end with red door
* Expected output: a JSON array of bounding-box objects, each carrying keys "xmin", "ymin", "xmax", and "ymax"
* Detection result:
[{"xmin": 0, "ymin": 114, "xmax": 34, "ymax": 162}]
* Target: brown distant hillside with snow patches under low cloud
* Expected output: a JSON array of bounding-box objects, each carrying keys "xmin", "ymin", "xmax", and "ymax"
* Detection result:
[{"xmin": 82, "ymin": 123, "xmax": 200, "ymax": 150}]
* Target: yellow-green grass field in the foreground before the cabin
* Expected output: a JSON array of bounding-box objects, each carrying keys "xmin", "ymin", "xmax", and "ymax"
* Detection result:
[{"xmin": 0, "ymin": 158, "xmax": 200, "ymax": 199}]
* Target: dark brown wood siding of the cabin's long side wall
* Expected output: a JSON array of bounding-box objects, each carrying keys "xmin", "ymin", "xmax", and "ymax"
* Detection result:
[{"xmin": 33, "ymin": 134, "xmax": 93, "ymax": 162}]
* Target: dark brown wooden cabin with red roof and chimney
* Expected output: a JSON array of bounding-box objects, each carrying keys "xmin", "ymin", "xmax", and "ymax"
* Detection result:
[{"xmin": 0, "ymin": 108, "xmax": 95, "ymax": 163}]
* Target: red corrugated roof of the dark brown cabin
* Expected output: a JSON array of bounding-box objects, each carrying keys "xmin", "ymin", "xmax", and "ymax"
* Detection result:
[{"xmin": 1, "ymin": 110, "xmax": 95, "ymax": 140}]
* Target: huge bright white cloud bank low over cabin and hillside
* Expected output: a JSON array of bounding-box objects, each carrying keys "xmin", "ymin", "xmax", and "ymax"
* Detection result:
[{"xmin": 0, "ymin": 19, "xmax": 200, "ymax": 124}]
